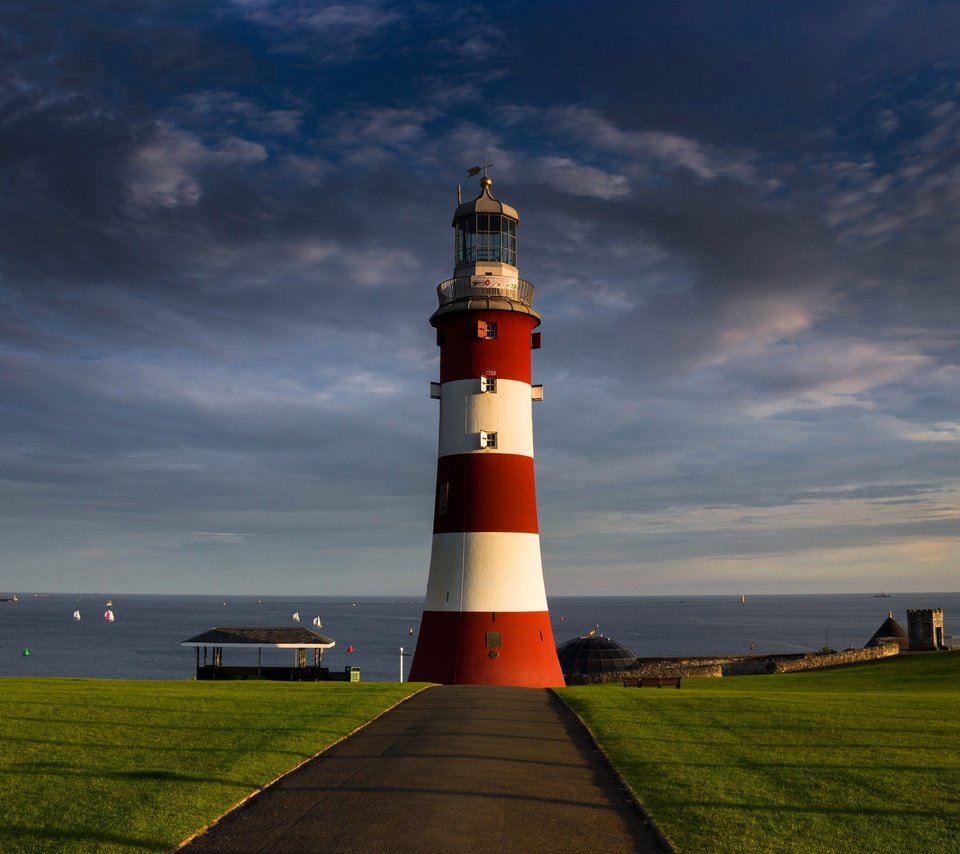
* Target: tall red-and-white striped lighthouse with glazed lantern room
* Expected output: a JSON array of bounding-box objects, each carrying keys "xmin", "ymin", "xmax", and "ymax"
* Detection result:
[{"xmin": 410, "ymin": 170, "xmax": 564, "ymax": 688}]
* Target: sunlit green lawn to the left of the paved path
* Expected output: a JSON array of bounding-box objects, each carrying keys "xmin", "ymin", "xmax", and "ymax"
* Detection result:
[{"xmin": 0, "ymin": 679, "xmax": 420, "ymax": 854}]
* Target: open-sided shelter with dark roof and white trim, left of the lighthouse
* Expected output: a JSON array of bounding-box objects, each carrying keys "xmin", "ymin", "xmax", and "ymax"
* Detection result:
[{"xmin": 180, "ymin": 626, "xmax": 336, "ymax": 682}]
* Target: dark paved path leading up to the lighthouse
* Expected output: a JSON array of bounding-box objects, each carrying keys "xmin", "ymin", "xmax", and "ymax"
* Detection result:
[{"xmin": 182, "ymin": 685, "xmax": 662, "ymax": 854}]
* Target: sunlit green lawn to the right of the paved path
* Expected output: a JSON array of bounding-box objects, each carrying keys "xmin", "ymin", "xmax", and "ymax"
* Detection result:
[{"xmin": 559, "ymin": 653, "xmax": 960, "ymax": 854}]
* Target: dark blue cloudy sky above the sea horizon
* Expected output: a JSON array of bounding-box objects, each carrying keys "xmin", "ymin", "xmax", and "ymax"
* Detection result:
[{"xmin": 0, "ymin": 0, "xmax": 960, "ymax": 596}]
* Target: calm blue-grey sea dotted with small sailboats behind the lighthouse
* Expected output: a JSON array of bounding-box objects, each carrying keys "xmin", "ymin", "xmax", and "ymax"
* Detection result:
[{"xmin": 0, "ymin": 593, "xmax": 960, "ymax": 682}]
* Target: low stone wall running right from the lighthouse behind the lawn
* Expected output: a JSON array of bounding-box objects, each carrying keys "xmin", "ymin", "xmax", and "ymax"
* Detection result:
[{"xmin": 566, "ymin": 644, "xmax": 900, "ymax": 685}]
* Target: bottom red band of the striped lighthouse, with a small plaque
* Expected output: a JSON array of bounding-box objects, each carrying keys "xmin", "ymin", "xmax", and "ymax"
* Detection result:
[{"xmin": 410, "ymin": 611, "xmax": 564, "ymax": 688}]
